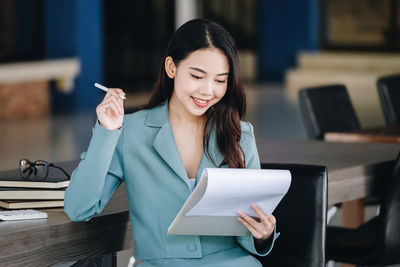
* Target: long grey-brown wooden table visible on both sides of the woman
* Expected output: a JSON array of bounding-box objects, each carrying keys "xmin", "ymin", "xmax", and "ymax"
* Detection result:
[{"xmin": 0, "ymin": 139, "xmax": 400, "ymax": 266}]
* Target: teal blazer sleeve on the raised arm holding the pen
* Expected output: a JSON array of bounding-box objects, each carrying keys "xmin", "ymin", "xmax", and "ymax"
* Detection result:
[{"xmin": 64, "ymin": 122, "xmax": 123, "ymax": 221}]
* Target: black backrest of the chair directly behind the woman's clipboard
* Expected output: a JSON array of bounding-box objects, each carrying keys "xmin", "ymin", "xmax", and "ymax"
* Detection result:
[{"xmin": 259, "ymin": 164, "xmax": 327, "ymax": 267}]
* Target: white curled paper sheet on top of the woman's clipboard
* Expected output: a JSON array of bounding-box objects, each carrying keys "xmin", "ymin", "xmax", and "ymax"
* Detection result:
[{"xmin": 186, "ymin": 168, "xmax": 291, "ymax": 217}]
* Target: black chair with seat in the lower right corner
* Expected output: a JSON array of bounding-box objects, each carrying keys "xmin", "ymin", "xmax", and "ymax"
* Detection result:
[{"xmin": 326, "ymin": 153, "xmax": 400, "ymax": 266}]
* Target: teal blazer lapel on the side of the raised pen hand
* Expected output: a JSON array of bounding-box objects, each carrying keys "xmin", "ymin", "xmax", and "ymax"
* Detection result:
[{"xmin": 146, "ymin": 101, "xmax": 189, "ymax": 186}]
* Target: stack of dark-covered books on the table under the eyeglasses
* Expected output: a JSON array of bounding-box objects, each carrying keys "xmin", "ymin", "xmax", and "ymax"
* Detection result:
[{"xmin": 0, "ymin": 170, "xmax": 69, "ymax": 209}]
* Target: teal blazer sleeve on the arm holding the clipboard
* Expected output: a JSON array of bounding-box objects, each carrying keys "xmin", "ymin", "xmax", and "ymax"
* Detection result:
[{"xmin": 236, "ymin": 122, "xmax": 280, "ymax": 256}]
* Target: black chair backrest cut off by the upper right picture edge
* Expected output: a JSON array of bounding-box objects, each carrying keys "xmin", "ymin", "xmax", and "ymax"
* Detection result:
[{"xmin": 377, "ymin": 74, "xmax": 400, "ymax": 125}]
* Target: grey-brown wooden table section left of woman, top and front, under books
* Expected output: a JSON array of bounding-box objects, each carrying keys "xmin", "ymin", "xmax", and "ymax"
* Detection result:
[{"xmin": 0, "ymin": 161, "xmax": 133, "ymax": 267}]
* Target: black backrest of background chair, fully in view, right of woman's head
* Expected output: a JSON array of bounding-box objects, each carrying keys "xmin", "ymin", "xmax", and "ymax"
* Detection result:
[{"xmin": 299, "ymin": 85, "xmax": 360, "ymax": 139}]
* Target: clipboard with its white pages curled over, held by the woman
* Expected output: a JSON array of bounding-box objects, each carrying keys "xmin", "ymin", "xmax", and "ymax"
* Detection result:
[{"xmin": 168, "ymin": 168, "xmax": 291, "ymax": 236}]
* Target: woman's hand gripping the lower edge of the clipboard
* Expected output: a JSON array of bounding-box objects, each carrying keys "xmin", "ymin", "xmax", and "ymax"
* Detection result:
[{"xmin": 237, "ymin": 204, "xmax": 276, "ymax": 240}]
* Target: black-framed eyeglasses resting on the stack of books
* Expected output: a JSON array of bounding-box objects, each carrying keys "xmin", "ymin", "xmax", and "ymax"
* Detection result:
[{"xmin": 19, "ymin": 159, "xmax": 71, "ymax": 181}]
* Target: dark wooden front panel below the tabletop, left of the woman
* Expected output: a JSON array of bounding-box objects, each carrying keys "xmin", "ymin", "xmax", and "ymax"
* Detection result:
[{"xmin": 0, "ymin": 212, "xmax": 133, "ymax": 266}]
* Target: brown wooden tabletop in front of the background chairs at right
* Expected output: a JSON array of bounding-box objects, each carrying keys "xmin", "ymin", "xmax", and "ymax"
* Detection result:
[{"xmin": 324, "ymin": 125, "xmax": 400, "ymax": 143}]
